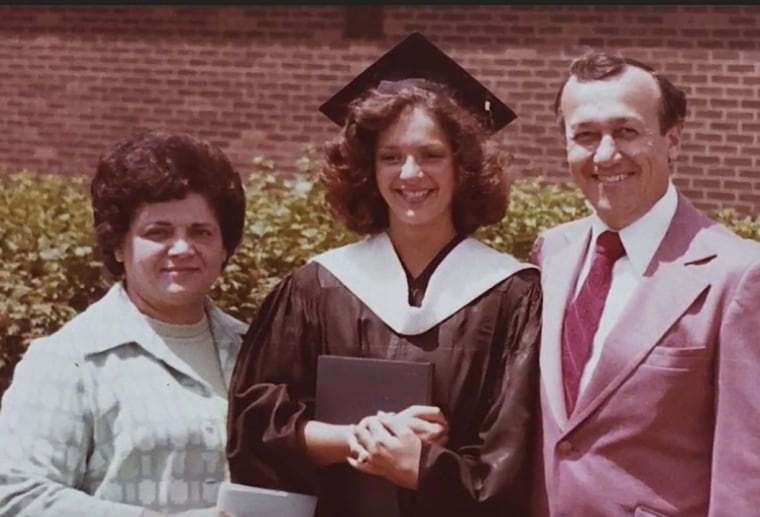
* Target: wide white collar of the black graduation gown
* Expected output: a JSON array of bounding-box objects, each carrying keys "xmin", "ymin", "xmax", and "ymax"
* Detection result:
[{"xmin": 311, "ymin": 233, "xmax": 534, "ymax": 335}]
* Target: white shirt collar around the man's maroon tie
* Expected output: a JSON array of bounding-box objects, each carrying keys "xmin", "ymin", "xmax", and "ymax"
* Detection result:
[{"xmin": 591, "ymin": 180, "xmax": 678, "ymax": 276}]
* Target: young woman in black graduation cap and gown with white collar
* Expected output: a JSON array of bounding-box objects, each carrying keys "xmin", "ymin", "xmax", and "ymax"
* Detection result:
[{"xmin": 227, "ymin": 34, "xmax": 541, "ymax": 517}]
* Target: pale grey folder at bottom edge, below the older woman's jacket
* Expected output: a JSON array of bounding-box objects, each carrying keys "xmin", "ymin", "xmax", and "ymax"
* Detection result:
[{"xmin": 216, "ymin": 481, "xmax": 317, "ymax": 517}]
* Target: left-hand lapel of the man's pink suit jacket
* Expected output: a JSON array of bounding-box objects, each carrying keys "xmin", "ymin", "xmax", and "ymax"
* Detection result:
[{"xmin": 540, "ymin": 224, "xmax": 591, "ymax": 427}]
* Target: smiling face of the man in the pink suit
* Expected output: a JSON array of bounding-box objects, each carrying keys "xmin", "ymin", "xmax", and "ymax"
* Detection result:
[{"xmin": 561, "ymin": 67, "xmax": 681, "ymax": 229}]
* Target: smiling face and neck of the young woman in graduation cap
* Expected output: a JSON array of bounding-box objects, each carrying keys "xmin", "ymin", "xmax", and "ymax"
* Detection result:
[{"xmin": 375, "ymin": 107, "xmax": 456, "ymax": 240}]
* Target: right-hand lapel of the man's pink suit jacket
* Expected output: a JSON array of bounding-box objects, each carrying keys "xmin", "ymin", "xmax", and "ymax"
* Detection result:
[{"xmin": 565, "ymin": 196, "xmax": 715, "ymax": 432}]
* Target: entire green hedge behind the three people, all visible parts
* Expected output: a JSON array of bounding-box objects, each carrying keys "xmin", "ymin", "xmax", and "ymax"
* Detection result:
[{"xmin": 0, "ymin": 149, "xmax": 760, "ymax": 393}]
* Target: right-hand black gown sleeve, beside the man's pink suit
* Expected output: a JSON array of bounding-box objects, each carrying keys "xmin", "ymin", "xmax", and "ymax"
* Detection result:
[{"xmin": 414, "ymin": 270, "xmax": 542, "ymax": 517}]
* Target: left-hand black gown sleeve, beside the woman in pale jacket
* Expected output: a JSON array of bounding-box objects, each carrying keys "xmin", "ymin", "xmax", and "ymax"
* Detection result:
[{"xmin": 226, "ymin": 266, "xmax": 319, "ymax": 493}]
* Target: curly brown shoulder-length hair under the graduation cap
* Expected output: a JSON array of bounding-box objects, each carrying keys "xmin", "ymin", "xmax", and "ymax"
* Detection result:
[{"xmin": 320, "ymin": 79, "xmax": 510, "ymax": 235}]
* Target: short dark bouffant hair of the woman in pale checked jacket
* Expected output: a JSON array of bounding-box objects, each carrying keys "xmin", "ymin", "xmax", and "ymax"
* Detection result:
[{"xmin": 90, "ymin": 130, "xmax": 245, "ymax": 275}]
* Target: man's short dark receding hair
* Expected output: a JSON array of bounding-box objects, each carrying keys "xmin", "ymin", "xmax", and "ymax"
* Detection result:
[{"xmin": 554, "ymin": 52, "xmax": 686, "ymax": 136}]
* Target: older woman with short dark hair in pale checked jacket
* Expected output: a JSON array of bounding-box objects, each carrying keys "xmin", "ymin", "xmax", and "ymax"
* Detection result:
[{"xmin": 0, "ymin": 131, "xmax": 245, "ymax": 517}]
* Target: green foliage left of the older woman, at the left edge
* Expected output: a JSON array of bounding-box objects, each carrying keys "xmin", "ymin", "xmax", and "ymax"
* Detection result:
[{"xmin": 0, "ymin": 172, "xmax": 108, "ymax": 398}]
